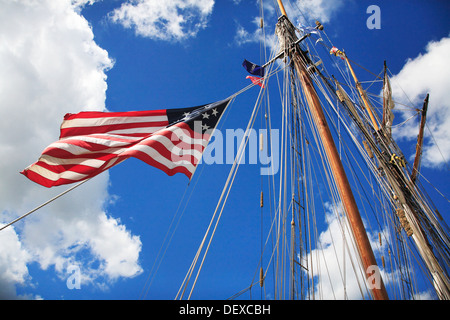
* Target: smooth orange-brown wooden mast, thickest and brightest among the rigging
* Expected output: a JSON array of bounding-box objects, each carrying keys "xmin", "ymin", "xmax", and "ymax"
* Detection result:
[{"xmin": 272, "ymin": 0, "xmax": 389, "ymax": 300}]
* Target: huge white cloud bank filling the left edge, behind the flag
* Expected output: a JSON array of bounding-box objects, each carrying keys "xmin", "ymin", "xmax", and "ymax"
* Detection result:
[{"xmin": 0, "ymin": 0, "xmax": 142, "ymax": 298}]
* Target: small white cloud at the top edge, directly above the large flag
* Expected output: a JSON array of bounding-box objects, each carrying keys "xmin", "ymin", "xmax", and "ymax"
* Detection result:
[{"xmin": 110, "ymin": 0, "xmax": 214, "ymax": 40}]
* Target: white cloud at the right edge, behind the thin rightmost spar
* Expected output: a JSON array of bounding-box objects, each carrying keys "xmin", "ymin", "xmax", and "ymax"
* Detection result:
[{"xmin": 391, "ymin": 37, "xmax": 450, "ymax": 167}]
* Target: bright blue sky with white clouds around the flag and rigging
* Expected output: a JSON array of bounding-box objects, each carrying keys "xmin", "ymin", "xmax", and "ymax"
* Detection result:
[{"xmin": 0, "ymin": 0, "xmax": 450, "ymax": 299}]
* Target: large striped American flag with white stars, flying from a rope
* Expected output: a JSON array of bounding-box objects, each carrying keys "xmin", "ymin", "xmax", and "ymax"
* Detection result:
[{"xmin": 21, "ymin": 99, "xmax": 231, "ymax": 187}]
